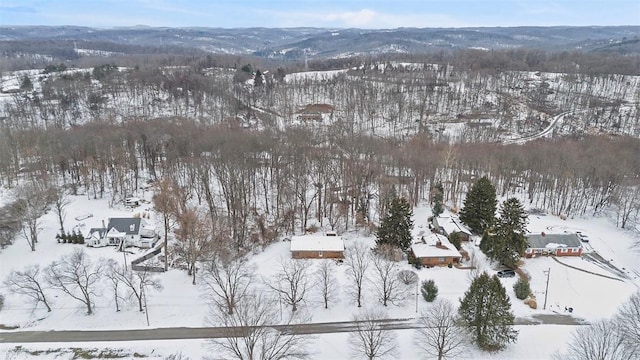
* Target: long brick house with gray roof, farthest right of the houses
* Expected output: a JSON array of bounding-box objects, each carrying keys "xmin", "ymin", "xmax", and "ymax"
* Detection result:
[{"xmin": 524, "ymin": 232, "xmax": 582, "ymax": 258}]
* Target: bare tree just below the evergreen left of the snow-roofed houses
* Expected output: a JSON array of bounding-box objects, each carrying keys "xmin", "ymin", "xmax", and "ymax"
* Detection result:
[{"xmin": 371, "ymin": 250, "xmax": 404, "ymax": 306}]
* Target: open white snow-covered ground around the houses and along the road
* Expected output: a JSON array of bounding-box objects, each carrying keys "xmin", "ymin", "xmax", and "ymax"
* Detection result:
[{"xmin": 0, "ymin": 192, "xmax": 640, "ymax": 359}]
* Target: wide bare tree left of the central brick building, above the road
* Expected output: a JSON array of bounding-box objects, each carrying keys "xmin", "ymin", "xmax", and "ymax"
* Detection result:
[{"xmin": 202, "ymin": 256, "xmax": 254, "ymax": 315}]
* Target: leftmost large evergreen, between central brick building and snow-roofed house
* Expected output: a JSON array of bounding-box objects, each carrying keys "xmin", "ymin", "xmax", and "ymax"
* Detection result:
[{"xmin": 376, "ymin": 197, "xmax": 413, "ymax": 252}]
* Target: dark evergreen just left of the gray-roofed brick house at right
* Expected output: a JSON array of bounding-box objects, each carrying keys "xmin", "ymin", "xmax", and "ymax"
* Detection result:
[{"xmin": 480, "ymin": 198, "xmax": 528, "ymax": 268}]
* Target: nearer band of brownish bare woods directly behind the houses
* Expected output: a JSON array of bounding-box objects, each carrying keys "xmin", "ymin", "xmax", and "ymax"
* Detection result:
[{"xmin": 0, "ymin": 118, "xmax": 640, "ymax": 252}]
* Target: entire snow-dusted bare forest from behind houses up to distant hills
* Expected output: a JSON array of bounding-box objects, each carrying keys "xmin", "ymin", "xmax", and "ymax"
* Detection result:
[{"xmin": 0, "ymin": 51, "xmax": 640, "ymax": 253}]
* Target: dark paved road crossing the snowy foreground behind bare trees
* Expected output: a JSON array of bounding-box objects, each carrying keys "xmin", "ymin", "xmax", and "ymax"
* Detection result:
[{"xmin": 0, "ymin": 314, "xmax": 585, "ymax": 344}]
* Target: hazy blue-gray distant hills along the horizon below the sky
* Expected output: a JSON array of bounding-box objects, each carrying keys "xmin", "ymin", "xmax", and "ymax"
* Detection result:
[{"xmin": 0, "ymin": 26, "xmax": 640, "ymax": 60}]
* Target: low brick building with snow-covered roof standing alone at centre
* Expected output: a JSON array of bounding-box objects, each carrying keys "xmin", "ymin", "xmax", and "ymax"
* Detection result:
[{"xmin": 291, "ymin": 235, "xmax": 344, "ymax": 259}]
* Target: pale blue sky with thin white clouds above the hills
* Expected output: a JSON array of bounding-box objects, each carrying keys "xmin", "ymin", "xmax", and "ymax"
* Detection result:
[{"xmin": 0, "ymin": 0, "xmax": 640, "ymax": 29}]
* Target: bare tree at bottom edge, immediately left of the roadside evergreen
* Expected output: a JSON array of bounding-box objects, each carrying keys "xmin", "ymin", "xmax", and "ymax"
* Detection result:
[{"xmin": 414, "ymin": 300, "xmax": 467, "ymax": 360}]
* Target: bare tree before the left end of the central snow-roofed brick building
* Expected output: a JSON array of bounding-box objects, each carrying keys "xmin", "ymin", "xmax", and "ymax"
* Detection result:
[{"xmin": 267, "ymin": 258, "xmax": 309, "ymax": 312}]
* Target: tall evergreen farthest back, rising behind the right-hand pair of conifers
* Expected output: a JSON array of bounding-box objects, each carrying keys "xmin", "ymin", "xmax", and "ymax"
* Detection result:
[{"xmin": 460, "ymin": 176, "xmax": 498, "ymax": 234}]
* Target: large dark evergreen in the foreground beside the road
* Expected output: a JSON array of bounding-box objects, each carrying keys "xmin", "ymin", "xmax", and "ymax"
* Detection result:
[{"xmin": 458, "ymin": 272, "xmax": 518, "ymax": 351}]
